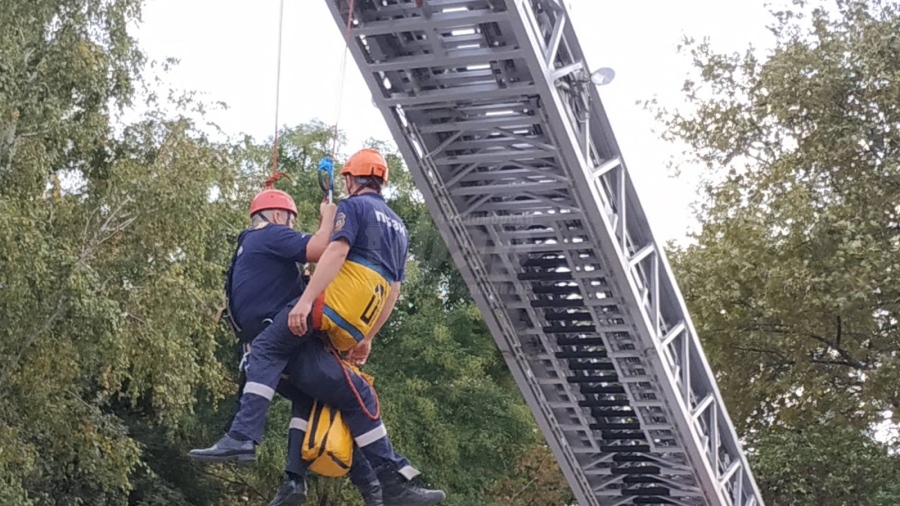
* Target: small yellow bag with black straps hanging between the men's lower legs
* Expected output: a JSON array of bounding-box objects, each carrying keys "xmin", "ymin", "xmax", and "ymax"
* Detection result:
[{"xmin": 303, "ymin": 401, "xmax": 353, "ymax": 478}]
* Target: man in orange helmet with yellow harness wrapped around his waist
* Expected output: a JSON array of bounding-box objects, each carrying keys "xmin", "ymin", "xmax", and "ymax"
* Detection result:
[{"xmin": 288, "ymin": 148, "xmax": 446, "ymax": 506}]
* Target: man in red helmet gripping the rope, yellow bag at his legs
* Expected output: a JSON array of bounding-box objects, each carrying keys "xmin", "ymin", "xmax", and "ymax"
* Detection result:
[{"xmin": 225, "ymin": 163, "xmax": 383, "ymax": 506}]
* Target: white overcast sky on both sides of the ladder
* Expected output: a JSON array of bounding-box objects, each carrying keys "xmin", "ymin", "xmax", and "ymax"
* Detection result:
[{"xmin": 130, "ymin": 0, "xmax": 771, "ymax": 245}]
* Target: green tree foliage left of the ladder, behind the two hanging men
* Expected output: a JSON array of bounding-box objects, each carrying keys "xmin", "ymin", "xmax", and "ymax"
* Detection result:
[{"xmin": 0, "ymin": 0, "xmax": 571, "ymax": 506}]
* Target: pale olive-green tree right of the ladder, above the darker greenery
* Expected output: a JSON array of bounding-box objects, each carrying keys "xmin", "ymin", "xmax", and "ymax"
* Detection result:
[{"xmin": 659, "ymin": 0, "xmax": 900, "ymax": 431}]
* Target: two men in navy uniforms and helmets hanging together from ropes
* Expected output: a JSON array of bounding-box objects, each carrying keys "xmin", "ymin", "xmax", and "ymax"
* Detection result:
[{"xmin": 189, "ymin": 149, "xmax": 445, "ymax": 506}]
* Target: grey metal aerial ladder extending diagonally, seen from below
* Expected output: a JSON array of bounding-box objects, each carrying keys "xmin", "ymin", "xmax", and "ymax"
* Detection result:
[{"xmin": 325, "ymin": 0, "xmax": 763, "ymax": 506}]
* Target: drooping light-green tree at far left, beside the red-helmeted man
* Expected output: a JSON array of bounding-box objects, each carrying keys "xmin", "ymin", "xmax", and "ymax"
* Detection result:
[{"xmin": 0, "ymin": 0, "xmax": 253, "ymax": 505}]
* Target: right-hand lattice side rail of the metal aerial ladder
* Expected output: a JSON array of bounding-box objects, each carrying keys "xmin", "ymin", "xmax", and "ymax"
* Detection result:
[{"xmin": 508, "ymin": 0, "xmax": 761, "ymax": 504}]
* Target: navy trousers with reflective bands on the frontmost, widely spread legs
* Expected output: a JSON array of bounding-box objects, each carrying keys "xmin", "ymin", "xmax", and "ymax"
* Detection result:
[{"xmin": 229, "ymin": 300, "xmax": 419, "ymax": 479}]
